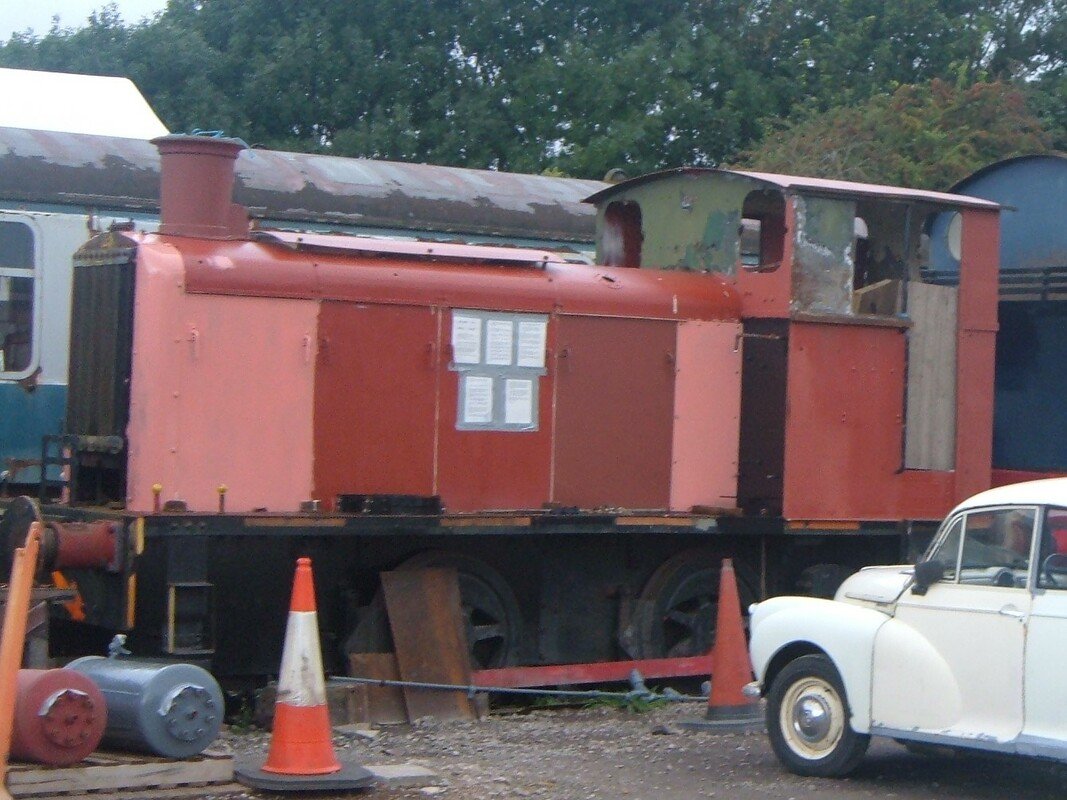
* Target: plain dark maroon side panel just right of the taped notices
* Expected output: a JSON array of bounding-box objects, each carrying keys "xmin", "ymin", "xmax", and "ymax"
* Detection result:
[{"xmin": 553, "ymin": 317, "xmax": 675, "ymax": 509}]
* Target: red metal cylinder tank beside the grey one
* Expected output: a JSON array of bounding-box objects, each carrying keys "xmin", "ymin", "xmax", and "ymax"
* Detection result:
[{"xmin": 11, "ymin": 670, "xmax": 108, "ymax": 766}]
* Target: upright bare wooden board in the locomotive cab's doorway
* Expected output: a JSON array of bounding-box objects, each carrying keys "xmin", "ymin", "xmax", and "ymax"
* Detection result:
[{"xmin": 904, "ymin": 282, "xmax": 958, "ymax": 469}]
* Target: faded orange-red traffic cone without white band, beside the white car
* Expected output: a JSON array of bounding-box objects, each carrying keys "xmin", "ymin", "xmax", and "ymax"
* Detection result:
[{"xmin": 684, "ymin": 558, "xmax": 763, "ymax": 731}]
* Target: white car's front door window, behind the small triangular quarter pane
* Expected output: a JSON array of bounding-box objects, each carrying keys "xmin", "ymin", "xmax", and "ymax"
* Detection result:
[{"xmin": 958, "ymin": 508, "xmax": 1037, "ymax": 587}]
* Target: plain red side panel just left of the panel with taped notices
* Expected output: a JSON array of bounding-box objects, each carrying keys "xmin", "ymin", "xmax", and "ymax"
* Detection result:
[{"xmin": 314, "ymin": 302, "xmax": 437, "ymax": 510}]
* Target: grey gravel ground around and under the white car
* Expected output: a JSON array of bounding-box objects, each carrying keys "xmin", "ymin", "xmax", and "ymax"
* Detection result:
[{"xmin": 203, "ymin": 703, "xmax": 1067, "ymax": 800}]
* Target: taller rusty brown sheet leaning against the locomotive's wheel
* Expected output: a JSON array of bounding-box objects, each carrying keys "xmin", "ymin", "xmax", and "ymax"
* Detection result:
[{"xmin": 382, "ymin": 570, "xmax": 475, "ymax": 720}]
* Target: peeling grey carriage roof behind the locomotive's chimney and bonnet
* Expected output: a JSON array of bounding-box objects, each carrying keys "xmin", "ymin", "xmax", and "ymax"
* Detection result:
[{"xmin": 0, "ymin": 128, "xmax": 605, "ymax": 244}]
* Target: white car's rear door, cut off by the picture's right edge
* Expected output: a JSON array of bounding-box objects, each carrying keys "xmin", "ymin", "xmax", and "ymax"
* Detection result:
[{"xmin": 1022, "ymin": 508, "xmax": 1067, "ymax": 757}]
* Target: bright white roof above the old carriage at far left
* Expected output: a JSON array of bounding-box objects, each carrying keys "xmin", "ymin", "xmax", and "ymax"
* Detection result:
[{"xmin": 0, "ymin": 69, "xmax": 168, "ymax": 139}]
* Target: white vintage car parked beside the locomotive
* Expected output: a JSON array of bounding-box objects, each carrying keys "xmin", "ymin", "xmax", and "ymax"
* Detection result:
[{"xmin": 750, "ymin": 478, "xmax": 1067, "ymax": 775}]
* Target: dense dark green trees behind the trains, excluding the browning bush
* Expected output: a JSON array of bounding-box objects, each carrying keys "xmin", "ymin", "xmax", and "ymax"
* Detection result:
[{"xmin": 0, "ymin": 0, "xmax": 1067, "ymax": 178}]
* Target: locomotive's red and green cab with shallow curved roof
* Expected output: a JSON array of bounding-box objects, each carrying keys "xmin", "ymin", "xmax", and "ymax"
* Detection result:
[{"xmin": 588, "ymin": 169, "xmax": 998, "ymax": 527}]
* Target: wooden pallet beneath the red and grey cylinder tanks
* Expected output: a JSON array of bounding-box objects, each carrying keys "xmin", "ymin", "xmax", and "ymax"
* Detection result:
[{"xmin": 7, "ymin": 753, "xmax": 234, "ymax": 797}]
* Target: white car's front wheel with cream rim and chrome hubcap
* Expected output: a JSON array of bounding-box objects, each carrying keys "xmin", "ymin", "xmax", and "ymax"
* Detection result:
[{"xmin": 767, "ymin": 655, "xmax": 871, "ymax": 778}]
